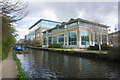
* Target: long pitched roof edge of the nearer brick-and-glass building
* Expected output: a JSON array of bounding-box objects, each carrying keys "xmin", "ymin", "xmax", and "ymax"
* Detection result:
[{"xmin": 44, "ymin": 18, "xmax": 110, "ymax": 32}]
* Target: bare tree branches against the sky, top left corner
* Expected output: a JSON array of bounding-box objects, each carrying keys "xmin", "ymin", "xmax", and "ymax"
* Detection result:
[{"xmin": 0, "ymin": 0, "xmax": 28, "ymax": 22}]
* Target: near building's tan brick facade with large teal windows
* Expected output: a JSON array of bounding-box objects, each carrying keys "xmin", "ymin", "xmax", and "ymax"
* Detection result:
[{"xmin": 42, "ymin": 18, "xmax": 109, "ymax": 48}]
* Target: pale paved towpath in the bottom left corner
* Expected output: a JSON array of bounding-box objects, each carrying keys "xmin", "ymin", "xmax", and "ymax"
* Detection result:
[{"xmin": 0, "ymin": 52, "xmax": 17, "ymax": 78}]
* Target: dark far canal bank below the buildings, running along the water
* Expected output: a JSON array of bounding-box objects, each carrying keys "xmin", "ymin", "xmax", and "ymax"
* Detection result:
[{"xmin": 29, "ymin": 47, "xmax": 110, "ymax": 61}]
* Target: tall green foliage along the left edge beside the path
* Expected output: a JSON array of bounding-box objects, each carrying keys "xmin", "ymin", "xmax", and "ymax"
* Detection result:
[{"xmin": 2, "ymin": 16, "xmax": 16, "ymax": 60}]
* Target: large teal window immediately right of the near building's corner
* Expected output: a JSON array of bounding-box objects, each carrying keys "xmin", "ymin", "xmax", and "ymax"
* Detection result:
[{"xmin": 81, "ymin": 31, "xmax": 90, "ymax": 45}]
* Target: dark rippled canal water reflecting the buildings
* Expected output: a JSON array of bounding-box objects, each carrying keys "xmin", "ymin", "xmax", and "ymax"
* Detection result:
[{"xmin": 17, "ymin": 49, "xmax": 120, "ymax": 79}]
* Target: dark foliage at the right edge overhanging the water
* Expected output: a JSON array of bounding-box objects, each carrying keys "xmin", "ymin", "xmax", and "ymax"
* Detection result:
[{"xmin": 107, "ymin": 46, "xmax": 120, "ymax": 61}]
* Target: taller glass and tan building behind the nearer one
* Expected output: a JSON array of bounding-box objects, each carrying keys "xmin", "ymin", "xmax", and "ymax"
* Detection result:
[{"xmin": 27, "ymin": 19, "xmax": 61, "ymax": 46}]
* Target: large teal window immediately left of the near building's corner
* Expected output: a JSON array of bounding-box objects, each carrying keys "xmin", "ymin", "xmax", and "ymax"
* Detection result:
[{"xmin": 69, "ymin": 31, "xmax": 77, "ymax": 45}]
